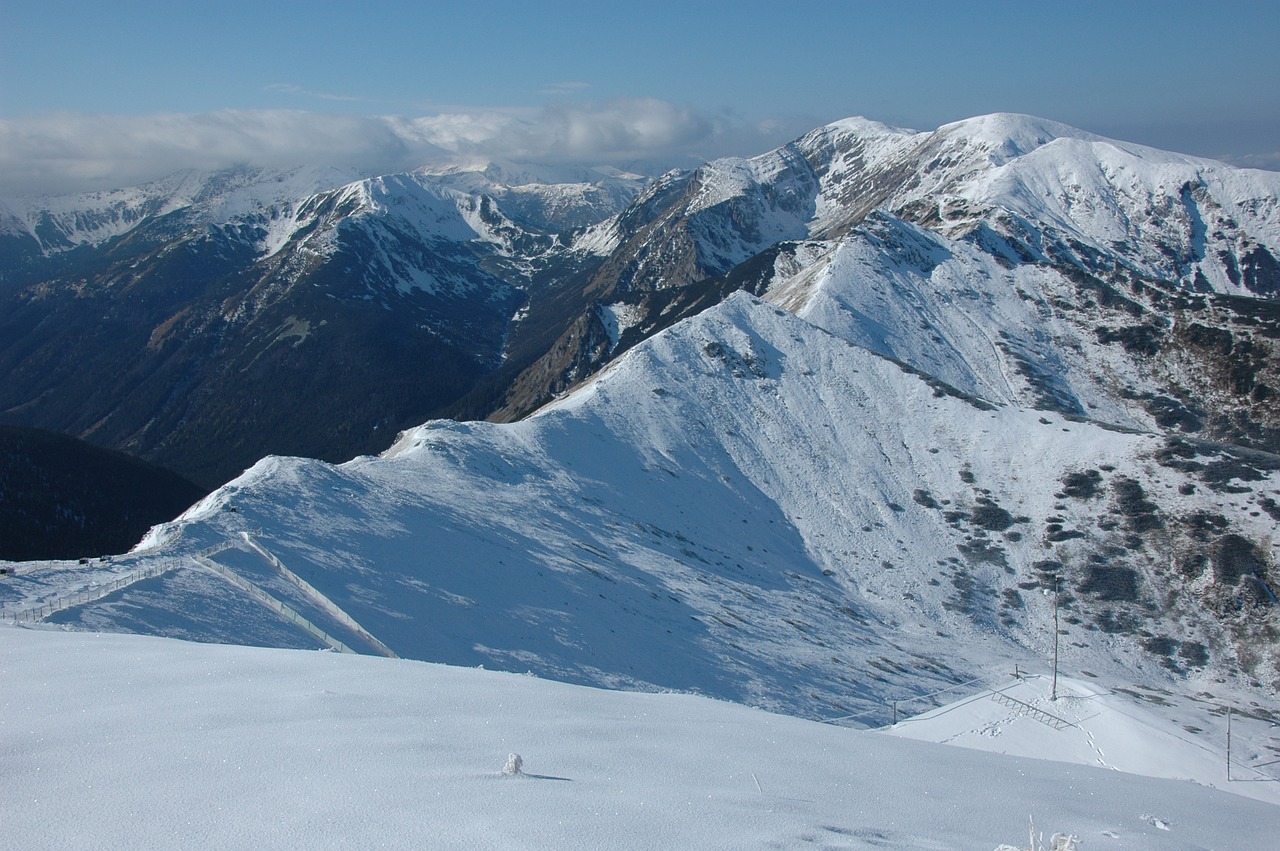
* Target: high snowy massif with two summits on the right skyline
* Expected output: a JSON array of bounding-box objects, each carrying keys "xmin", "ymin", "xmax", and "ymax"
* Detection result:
[{"xmin": 684, "ymin": 113, "xmax": 1280, "ymax": 296}]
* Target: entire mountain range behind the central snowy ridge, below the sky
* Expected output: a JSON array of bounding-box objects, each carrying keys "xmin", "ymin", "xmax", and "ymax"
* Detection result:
[{"xmin": 0, "ymin": 115, "xmax": 1280, "ymax": 486}]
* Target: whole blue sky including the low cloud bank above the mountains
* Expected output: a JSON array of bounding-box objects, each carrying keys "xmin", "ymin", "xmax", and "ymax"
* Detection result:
[{"xmin": 0, "ymin": 0, "xmax": 1280, "ymax": 188}]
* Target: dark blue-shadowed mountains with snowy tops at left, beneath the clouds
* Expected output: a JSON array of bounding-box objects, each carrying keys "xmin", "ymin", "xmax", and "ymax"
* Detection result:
[{"xmin": 0, "ymin": 159, "xmax": 639, "ymax": 486}]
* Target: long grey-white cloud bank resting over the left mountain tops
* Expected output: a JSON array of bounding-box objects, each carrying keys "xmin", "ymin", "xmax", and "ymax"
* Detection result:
[{"xmin": 0, "ymin": 97, "xmax": 788, "ymax": 197}]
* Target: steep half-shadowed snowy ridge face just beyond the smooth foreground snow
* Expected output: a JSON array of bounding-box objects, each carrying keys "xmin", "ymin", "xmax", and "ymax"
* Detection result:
[{"xmin": 22, "ymin": 294, "xmax": 1280, "ymax": 722}]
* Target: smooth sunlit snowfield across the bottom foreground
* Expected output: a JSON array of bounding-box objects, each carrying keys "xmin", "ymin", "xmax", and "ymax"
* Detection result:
[{"xmin": 0, "ymin": 627, "xmax": 1280, "ymax": 850}]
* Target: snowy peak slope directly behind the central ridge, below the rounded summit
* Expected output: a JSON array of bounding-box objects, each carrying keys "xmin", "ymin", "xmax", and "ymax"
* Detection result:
[{"xmin": 765, "ymin": 212, "xmax": 1153, "ymax": 427}]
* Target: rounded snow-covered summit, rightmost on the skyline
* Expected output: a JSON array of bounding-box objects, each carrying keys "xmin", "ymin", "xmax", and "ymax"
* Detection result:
[{"xmin": 922, "ymin": 115, "xmax": 1280, "ymax": 296}]
